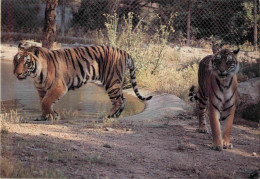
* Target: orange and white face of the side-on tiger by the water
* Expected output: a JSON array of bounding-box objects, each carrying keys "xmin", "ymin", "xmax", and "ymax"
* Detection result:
[{"xmin": 13, "ymin": 52, "xmax": 36, "ymax": 80}]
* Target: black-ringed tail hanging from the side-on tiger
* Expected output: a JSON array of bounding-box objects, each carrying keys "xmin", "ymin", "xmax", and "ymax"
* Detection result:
[{"xmin": 128, "ymin": 58, "xmax": 152, "ymax": 101}]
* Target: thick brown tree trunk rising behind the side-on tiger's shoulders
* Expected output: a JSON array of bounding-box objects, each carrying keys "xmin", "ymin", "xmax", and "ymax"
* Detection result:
[{"xmin": 42, "ymin": 0, "xmax": 58, "ymax": 49}]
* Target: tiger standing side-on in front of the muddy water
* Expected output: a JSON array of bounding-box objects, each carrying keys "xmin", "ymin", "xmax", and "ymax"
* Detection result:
[{"xmin": 13, "ymin": 44, "xmax": 152, "ymax": 120}]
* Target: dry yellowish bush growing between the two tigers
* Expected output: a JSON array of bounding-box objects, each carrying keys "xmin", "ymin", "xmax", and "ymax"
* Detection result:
[{"xmin": 104, "ymin": 13, "xmax": 198, "ymax": 99}]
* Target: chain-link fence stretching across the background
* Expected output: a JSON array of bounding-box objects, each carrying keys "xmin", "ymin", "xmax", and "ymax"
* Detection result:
[{"xmin": 1, "ymin": 0, "xmax": 260, "ymax": 50}]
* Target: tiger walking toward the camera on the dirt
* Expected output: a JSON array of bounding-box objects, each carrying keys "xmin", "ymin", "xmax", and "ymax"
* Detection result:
[{"xmin": 189, "ymin": 49, "xmax": 239, "ymax": 150}]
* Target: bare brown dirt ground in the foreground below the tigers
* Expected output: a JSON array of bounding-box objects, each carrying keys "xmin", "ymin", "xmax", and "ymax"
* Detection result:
[{"xmin": 1, "ymin": 113, "xmax": 260, "ymax": 178}]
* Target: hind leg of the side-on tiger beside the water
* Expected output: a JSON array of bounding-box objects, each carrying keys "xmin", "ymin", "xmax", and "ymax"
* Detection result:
[{"xmin": 107, "ymin": 84, "xmax": 126, "ymax": 118}]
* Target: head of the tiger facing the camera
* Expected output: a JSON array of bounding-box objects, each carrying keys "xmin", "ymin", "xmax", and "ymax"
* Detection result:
[{"xmin": 209, "ymin": 49, "xmax": 239, "ymax": 78}]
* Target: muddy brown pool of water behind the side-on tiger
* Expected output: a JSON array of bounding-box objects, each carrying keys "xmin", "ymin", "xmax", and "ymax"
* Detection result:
[{"xmin": 1, "ymin": 61, "xmax": 145, "ymax": 117}]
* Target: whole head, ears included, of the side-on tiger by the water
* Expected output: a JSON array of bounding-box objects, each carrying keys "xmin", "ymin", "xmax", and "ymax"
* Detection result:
[{"xmin": 13, "ymin": 43, "xmax": 41, "ymax": 80}]
